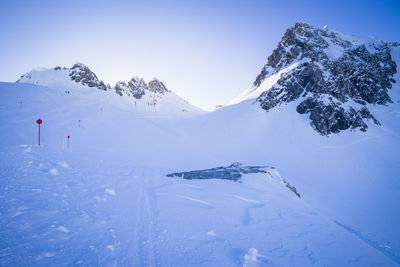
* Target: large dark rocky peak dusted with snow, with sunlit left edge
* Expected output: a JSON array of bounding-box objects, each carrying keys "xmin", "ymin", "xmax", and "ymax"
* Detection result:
[{"xmin": 233, "ymin": 22, "xmax": 400, "ymax": 135}]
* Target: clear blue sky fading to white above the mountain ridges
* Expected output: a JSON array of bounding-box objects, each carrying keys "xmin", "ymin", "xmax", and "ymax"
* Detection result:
[{"xmin": 0, "ymin": 0, "xmax": 400, "ymax": 110}]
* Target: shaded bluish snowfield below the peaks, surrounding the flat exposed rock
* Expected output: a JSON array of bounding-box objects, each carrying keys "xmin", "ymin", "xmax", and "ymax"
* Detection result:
[{"xmin": 0, "ymin": 83, "xmax": 400, "ymax": 266}]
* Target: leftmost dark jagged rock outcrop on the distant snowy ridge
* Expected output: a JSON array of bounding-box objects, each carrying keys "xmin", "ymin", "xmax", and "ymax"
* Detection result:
[{"xmin": 69, "ymin": 63, "xmax": 107, "ymax": 90}]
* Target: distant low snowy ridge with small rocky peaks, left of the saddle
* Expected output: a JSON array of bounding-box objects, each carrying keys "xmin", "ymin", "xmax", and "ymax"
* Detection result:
[{"xmin": 17, "ymin": 63, "xmax": 203, "ymax": 116}]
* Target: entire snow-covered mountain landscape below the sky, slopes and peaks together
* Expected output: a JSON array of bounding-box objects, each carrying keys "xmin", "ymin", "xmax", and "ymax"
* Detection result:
[{"xmin": 0, "ymin": 23, "xmax": 400, "ymax": 266}]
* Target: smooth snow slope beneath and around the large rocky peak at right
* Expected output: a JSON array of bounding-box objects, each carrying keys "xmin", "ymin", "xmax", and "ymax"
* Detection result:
[{"xmin": 178, "ymin": 27, "xmax": 400, "ymax": 264}]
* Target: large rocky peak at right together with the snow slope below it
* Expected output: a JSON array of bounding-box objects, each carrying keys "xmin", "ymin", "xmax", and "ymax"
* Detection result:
[{"xmin": 192, "ymin": 23, "xmax": 400, "ymax": 263}]
